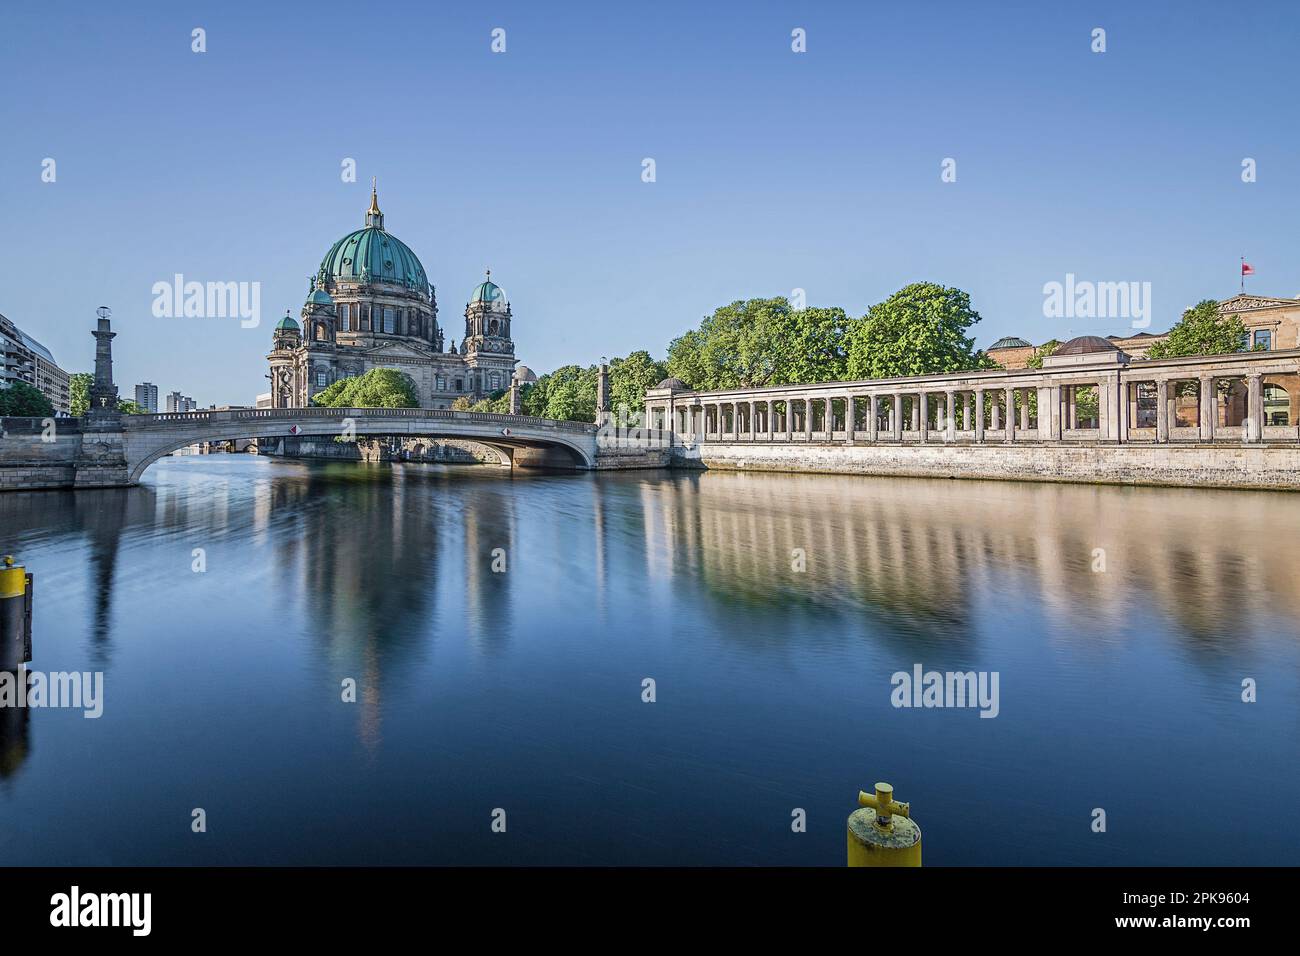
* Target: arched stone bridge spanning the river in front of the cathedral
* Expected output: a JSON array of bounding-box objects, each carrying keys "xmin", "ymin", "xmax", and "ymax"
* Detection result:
[{"xmin": 0, "ymin": 407, "xmax": 668, "ymax": 490}]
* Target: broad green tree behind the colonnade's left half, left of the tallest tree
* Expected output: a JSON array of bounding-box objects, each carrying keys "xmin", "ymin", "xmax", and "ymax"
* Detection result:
[{"xmin": 667, "ymin": 297, "xmax": 855, "ymax": 389}]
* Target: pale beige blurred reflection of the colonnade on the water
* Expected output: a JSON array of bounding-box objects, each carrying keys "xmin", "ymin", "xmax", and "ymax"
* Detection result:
[{"xmin": 644, "ymin": 472, "xmax": 1300, "ymax": 658}]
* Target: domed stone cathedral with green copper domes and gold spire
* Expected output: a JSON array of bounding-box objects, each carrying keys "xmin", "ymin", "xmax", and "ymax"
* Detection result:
[{"xmin": 267, "ymin": 187, "xmax": 536, "ymax": 408}]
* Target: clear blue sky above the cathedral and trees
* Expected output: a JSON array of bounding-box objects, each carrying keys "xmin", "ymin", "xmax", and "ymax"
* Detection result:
[{"xmin": 0, "ymin": 0, "xmax": 1300, "ymax": 406}]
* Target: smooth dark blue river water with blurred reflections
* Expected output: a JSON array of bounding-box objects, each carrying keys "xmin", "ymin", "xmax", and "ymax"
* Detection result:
[{"xmin": 0, "ymin": 455, "xmax": 1300, "ymax": 866}]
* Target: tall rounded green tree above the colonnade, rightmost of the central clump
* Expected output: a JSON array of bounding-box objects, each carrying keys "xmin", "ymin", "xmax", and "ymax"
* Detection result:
[{"xmin": 848, "ymin": 282, "xmax": 997, "ymax": 378}]
